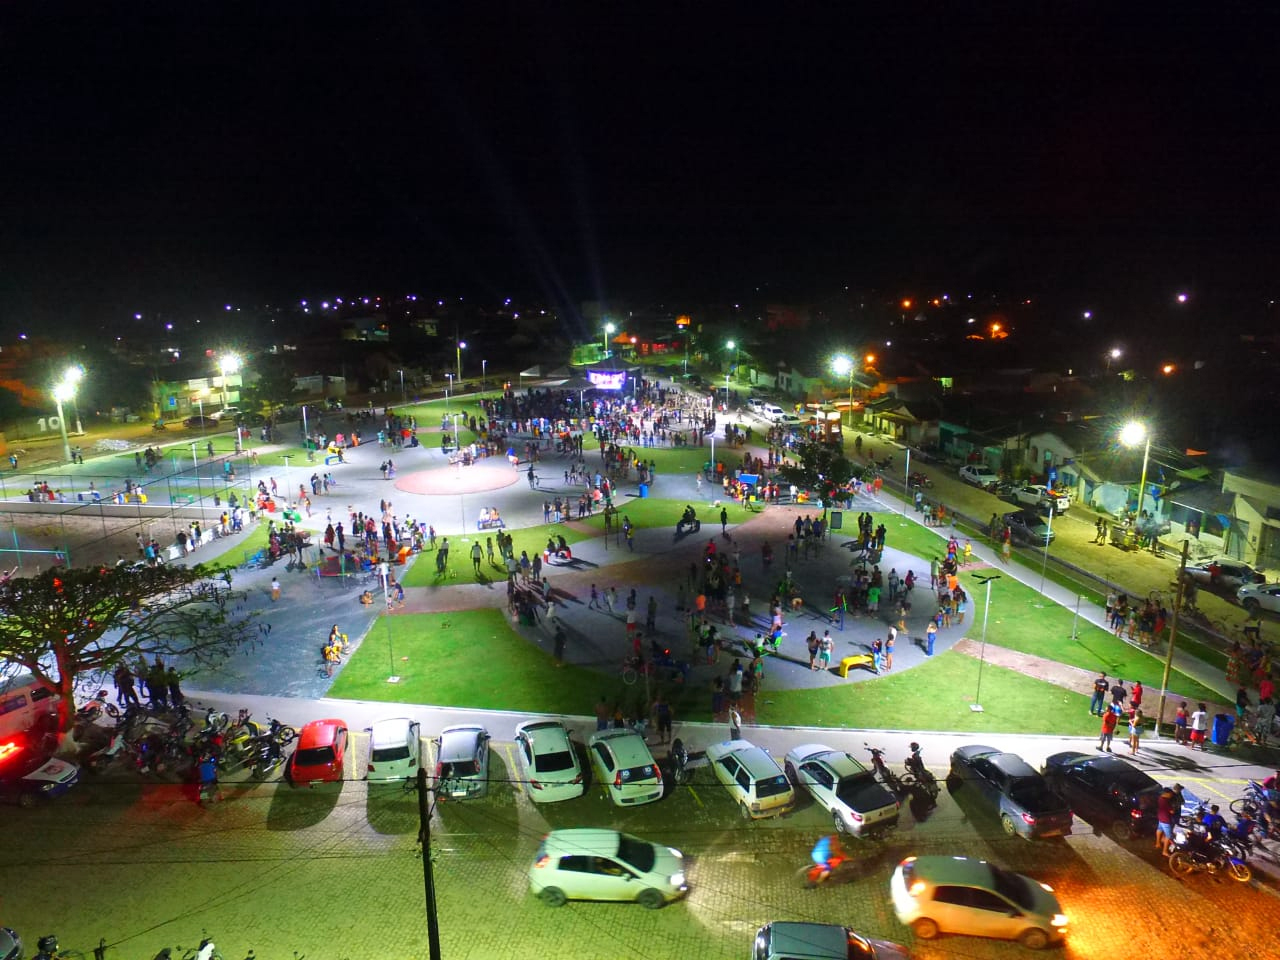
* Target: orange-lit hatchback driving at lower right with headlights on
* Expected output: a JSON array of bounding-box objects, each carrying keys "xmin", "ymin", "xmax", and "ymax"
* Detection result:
[{"xmin": 888, "ymin": 856, "xmax": 1068, "ymax": 950}]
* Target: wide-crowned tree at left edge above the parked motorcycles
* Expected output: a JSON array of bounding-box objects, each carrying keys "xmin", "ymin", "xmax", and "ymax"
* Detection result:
[{"xmin": 0, "ymin": 566, "xmax": 256, "ymax": 735}]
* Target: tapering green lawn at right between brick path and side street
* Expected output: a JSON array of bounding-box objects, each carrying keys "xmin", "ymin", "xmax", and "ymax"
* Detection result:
[{"xmin": 962, "ymin": 572, "xmax": 1221, "ymax": 700}]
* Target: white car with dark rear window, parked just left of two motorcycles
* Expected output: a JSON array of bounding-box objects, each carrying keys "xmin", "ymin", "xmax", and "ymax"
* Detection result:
[{"xmin": 786, "ymin": 744, "xmax": 899, "ymax": 836}]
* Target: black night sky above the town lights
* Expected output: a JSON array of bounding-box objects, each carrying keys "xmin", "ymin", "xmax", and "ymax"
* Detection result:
[{"xmin": 0, "ymin": 3, "xmax": 1280, "ymax": 335}]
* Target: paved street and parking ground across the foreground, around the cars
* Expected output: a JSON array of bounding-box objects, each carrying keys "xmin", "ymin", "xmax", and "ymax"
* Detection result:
[{"xmin": 0, "ymin": 731, "xmax": 1280, "ymax": 960}]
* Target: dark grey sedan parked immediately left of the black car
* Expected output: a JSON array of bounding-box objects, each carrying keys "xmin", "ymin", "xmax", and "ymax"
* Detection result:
[{"xmin": 947, "ymin": 744, "xmax": 1071, "ymax": 840}]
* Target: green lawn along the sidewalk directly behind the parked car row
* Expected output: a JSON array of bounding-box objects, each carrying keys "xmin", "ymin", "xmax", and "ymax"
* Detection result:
[{"xmin": 330, "ymin": 609, "xmax": 1096, "ymax": 735}]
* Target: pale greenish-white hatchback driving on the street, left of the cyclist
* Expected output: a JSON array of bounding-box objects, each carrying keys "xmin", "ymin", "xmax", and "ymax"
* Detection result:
[{"xmin": 529, "ymin": 828, "xmax": 689, "ymax": 910}]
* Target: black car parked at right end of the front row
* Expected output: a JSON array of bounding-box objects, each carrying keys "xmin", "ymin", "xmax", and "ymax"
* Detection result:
[{"xmin": 1043, "ymin": 750, "xmax": 1161, "ymax": 840}]
